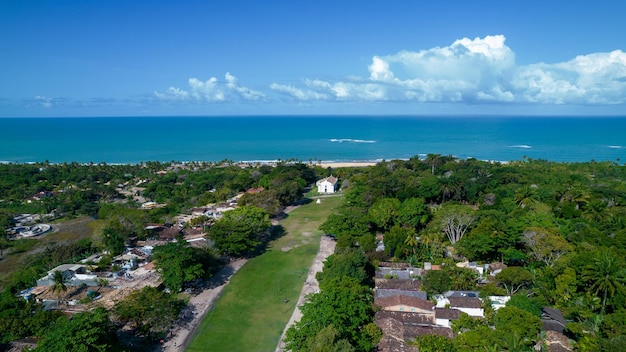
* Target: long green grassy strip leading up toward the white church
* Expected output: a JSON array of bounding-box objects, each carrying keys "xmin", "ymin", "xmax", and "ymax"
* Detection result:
[{"xmin": 187, "ymin": 197, "xmax": 342, "ymax": 352}]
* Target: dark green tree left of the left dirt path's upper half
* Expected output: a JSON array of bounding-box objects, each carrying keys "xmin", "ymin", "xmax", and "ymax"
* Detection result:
[{"xmin": 153, "ymin": 241, "xmax": 214, "ymax": 292}]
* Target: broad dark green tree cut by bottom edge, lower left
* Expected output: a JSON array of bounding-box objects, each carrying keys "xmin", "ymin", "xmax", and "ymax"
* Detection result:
[{"xmin": 33, "ymin": 308, "xmax": 119, "ymax": 352}]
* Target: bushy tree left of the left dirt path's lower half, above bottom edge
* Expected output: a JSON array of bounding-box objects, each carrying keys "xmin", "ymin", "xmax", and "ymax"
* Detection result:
[{"xmin": 113, "ymin": 286, "xmax": 186, "ymax": 338}]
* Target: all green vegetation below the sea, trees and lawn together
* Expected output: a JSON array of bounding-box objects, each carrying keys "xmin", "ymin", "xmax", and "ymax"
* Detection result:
[{"xmin": 0, "ymin": 155, "xmax": 626, "ymax": 351}]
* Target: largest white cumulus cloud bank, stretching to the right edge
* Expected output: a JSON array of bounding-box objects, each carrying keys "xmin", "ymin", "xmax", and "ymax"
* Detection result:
[{"xmin": 270, "ymin": 35, "xmax": 626, "ymax": 104}]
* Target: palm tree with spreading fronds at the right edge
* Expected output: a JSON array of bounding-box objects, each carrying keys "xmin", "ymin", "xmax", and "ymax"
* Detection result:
[{"xmin": 583, "ymin": 250, "xmax": 626, "ymax": 315}]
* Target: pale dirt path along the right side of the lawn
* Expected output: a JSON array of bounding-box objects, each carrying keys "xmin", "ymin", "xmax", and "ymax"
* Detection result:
[{"xmin": 276, "ymin": 236, "xmax": 337, "ymax": 352}]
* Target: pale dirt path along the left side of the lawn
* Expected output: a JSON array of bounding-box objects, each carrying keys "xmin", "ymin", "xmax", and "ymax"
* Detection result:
[{"xmin": 155, "ymin": 259, "xmax": 247, "ymax": 352}]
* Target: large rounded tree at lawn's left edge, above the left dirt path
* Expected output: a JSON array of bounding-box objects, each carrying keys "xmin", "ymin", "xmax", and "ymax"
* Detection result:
[{"xmin": 208, "ymin": 206, "xmax": 271, "ymax": 256}]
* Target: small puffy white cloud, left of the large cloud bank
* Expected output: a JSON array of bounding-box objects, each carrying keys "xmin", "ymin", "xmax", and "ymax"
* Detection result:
[{"xmin": 154, "ymin": 72, "xmax": 265, "ymax": 103}]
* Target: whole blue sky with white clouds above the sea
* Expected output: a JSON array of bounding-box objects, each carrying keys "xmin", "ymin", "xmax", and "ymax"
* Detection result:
[{"xmin": 0, "ymin": 0, "xmax": 626, "ymax": 117}]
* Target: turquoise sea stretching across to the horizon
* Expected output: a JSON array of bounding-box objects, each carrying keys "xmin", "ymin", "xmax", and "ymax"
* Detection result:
[{"xmin": 0, "ymin": 116, "xmax": 626, "ymax": 164}]
